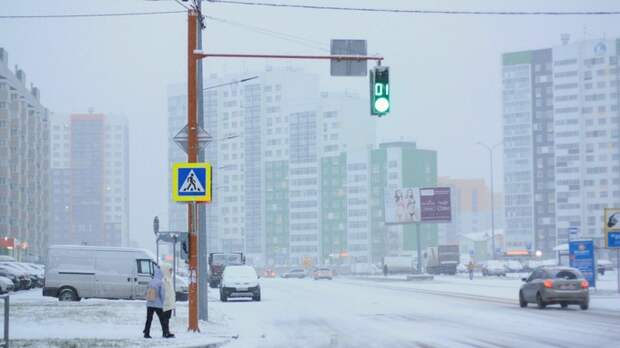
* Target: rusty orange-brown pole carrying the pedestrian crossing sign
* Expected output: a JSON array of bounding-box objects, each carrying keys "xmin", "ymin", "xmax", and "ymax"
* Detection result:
[{"xmin": 187, "ymin": 9, "xmax": 200, "ymax": 332}]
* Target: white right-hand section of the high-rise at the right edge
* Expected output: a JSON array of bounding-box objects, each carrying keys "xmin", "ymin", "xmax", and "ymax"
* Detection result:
[{"xmin": 553, "ymin": 39, "xmax": 620, "ymax": 247}]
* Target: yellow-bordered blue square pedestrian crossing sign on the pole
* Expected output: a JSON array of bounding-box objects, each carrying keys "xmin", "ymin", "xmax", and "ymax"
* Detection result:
[{"xmin": 172, "ymin": 163, "xmax": 211, "ymax": 202}]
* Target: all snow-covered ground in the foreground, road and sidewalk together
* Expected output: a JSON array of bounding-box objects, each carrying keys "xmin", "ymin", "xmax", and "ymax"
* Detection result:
[{"xmin": 4, "ymin": 272, "xmax": 620, "ymax": 348}]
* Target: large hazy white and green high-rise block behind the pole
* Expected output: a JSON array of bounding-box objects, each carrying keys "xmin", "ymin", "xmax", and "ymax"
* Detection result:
[{"xmin": 169, "ymin": 69, "xmax": 375, "ymax": 264}]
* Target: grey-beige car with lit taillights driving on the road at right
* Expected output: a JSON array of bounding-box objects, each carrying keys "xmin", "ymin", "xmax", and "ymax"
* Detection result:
[{"xmin": 519, "ymin": 266, "xmax": 590, "ymax": 310}]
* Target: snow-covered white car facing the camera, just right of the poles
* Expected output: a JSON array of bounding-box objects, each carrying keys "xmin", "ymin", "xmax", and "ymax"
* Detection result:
[{"xmin": 220, "ymin": 265, "xmax": 261, "ymax": 302}]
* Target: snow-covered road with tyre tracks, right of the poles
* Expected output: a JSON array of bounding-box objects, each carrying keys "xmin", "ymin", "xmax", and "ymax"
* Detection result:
[{"xmin": 219, "ymin": 278, "xmax": 620, "ymax": 348}]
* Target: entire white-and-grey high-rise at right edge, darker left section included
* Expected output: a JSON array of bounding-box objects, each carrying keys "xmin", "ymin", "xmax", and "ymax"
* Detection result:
[{"xmin": 503, "ymin": 39, "xmax": 620, "ymax": 255}]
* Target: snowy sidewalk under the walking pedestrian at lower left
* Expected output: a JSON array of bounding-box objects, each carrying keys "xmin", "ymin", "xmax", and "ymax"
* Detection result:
[{"xmin": 9, "ymin": 289, "xmax": 230, "ymax": 348}]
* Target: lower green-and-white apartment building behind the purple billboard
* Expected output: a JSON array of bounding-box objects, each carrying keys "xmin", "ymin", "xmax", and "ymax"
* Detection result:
[{"xmin": 332, "ymin": 141, "xmax": 438, "ymax": 263}]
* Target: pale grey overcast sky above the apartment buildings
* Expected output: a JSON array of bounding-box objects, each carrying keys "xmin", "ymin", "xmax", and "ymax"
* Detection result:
[{"xmin": 0, "ymin": 0, "xmax": 620, "ymax": 247}]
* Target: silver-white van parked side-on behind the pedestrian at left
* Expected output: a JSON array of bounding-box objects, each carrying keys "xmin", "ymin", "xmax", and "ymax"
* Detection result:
[{"xmin": 43, "ymin": 245, "xmax": 155, "ymax": 301}]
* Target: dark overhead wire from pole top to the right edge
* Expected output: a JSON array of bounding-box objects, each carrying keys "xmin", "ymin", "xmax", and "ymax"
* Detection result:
[{"xmin": 207, "ymin": 0, "xmax": 620, "ymax": 16}]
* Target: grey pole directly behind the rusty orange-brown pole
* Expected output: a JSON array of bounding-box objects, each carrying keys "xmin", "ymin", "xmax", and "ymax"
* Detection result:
[{"xmin": 196, "ymin": 0, "xmax": 209, "ymax": 321}]
